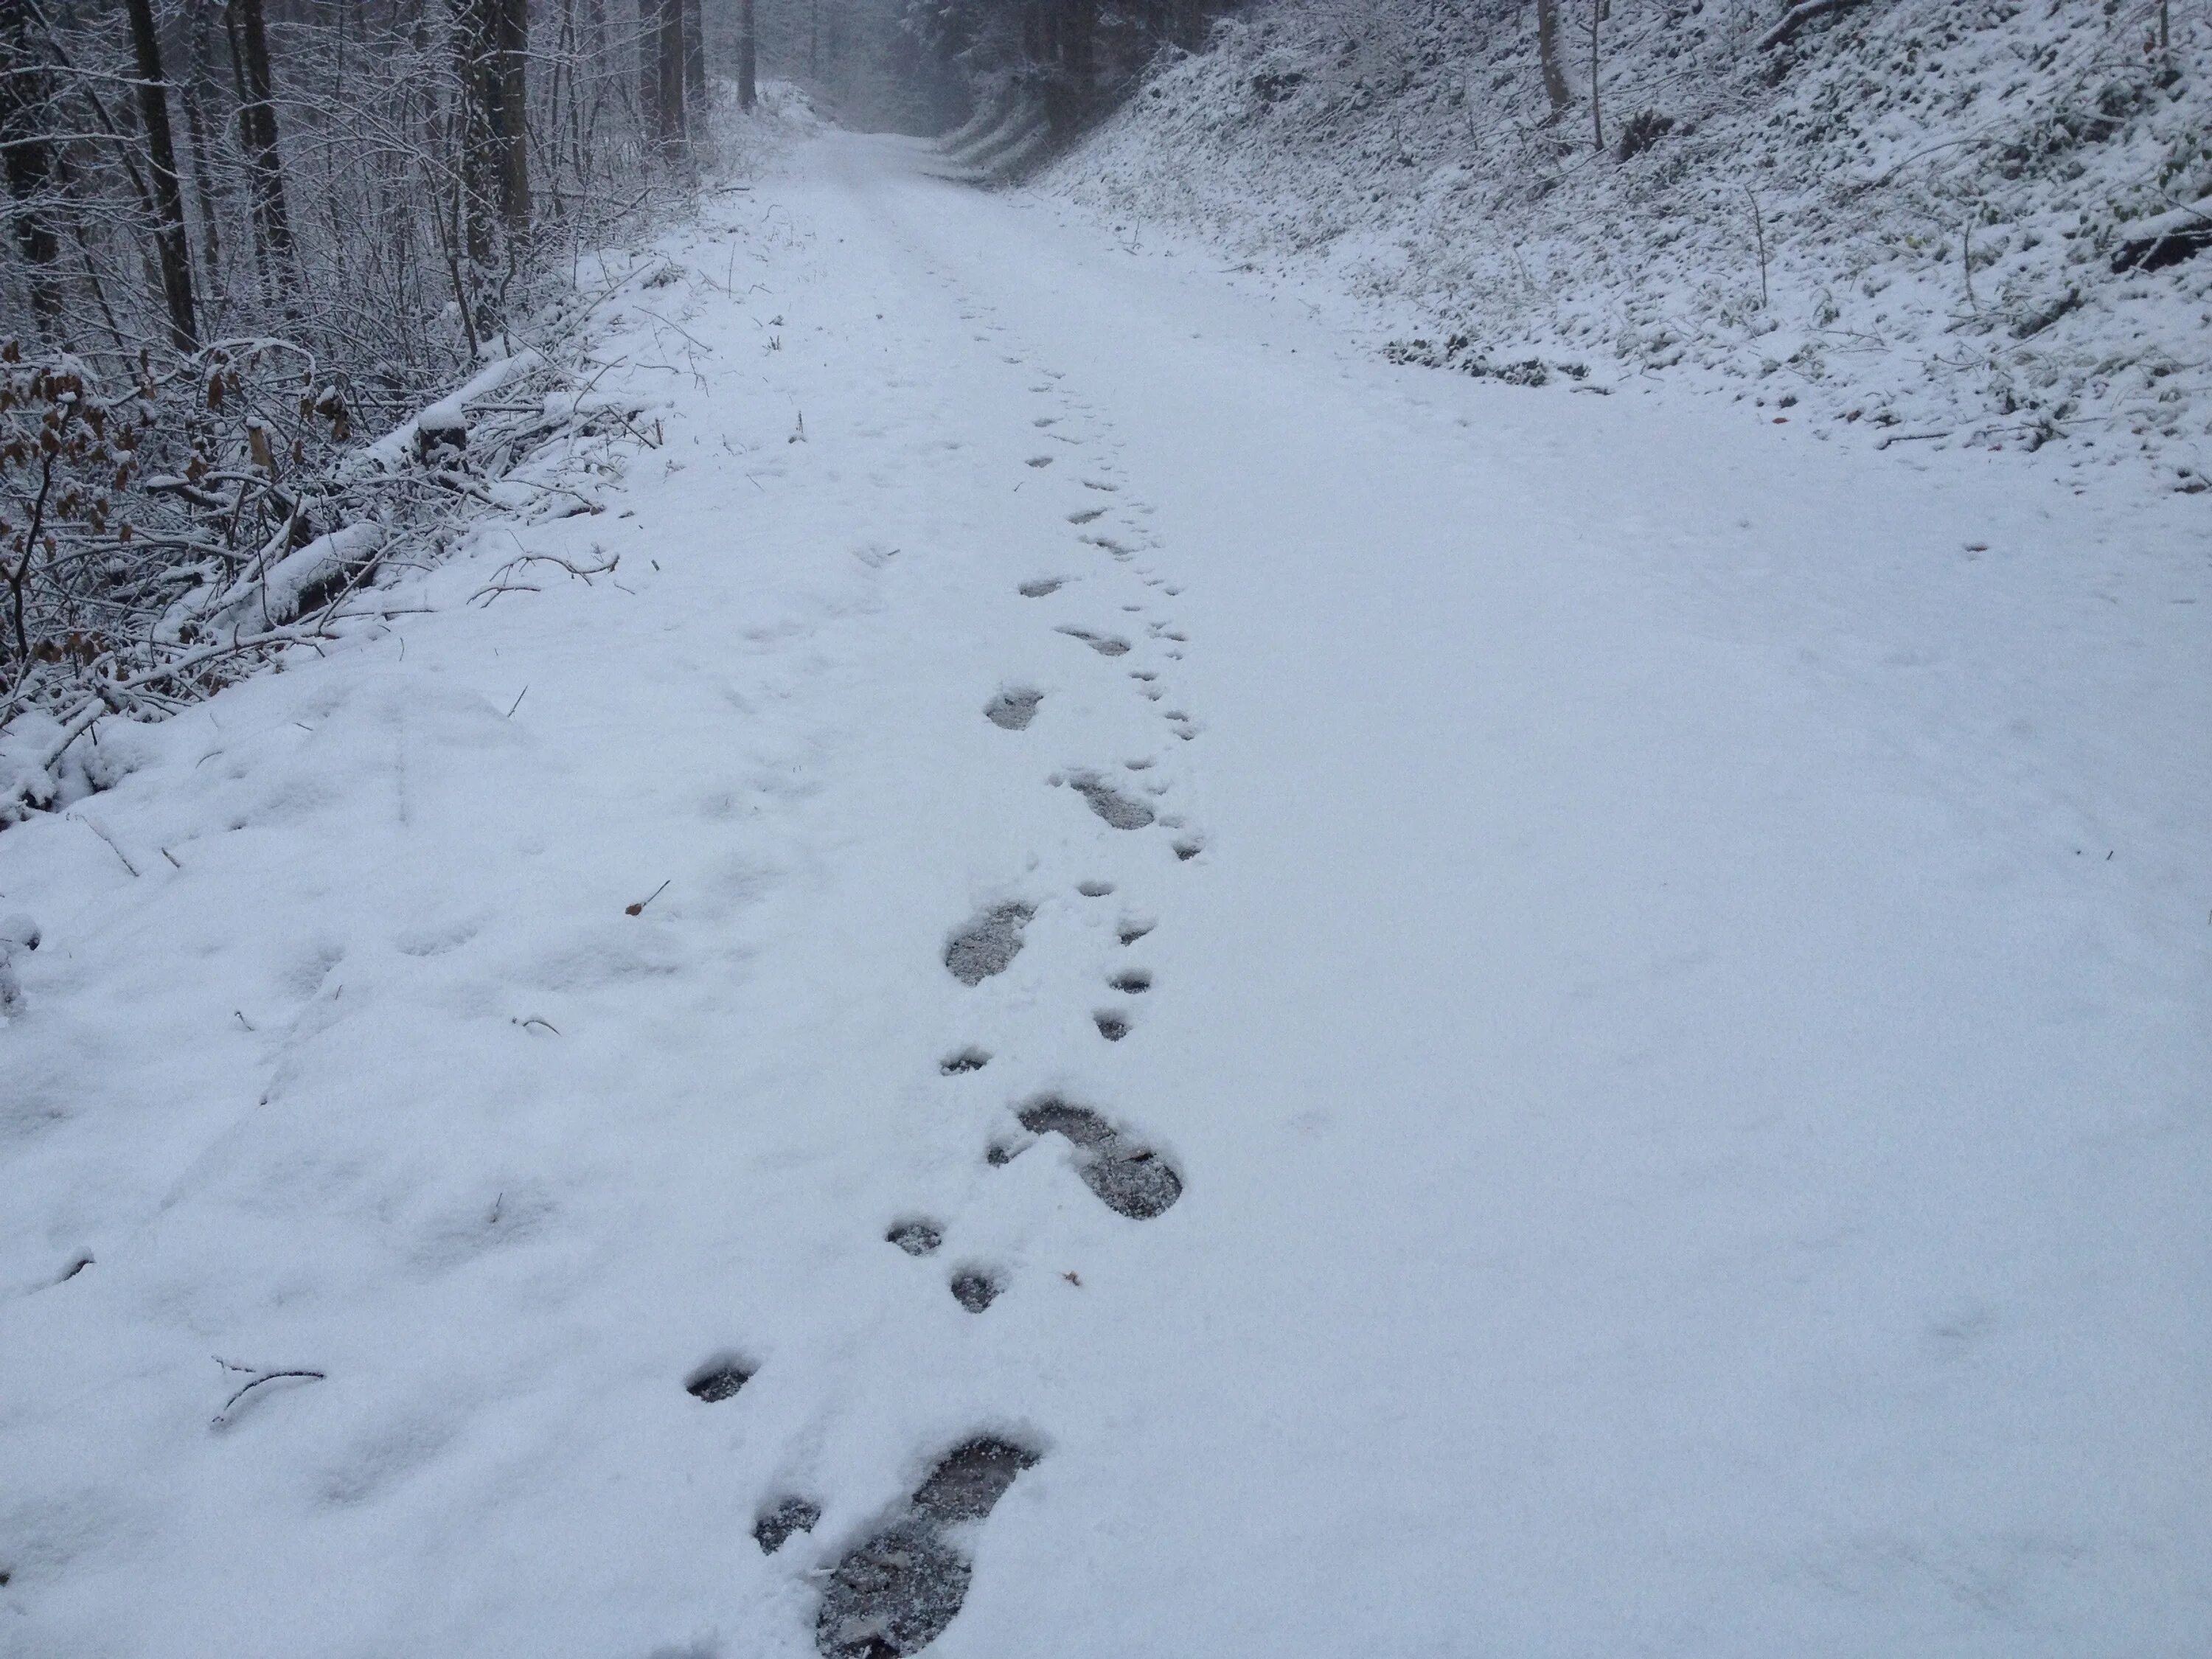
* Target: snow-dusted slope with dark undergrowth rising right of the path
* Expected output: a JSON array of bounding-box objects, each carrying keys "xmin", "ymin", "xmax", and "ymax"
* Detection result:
[{"xmin": 1042, "ymin": 0, "xmax": 2212, "ymax": 491}]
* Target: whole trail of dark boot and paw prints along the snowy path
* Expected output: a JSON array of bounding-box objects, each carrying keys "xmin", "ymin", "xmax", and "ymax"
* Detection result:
[{"xmin": 684, "ymin": 263, "xmax": 1203, "ymax": 1659}]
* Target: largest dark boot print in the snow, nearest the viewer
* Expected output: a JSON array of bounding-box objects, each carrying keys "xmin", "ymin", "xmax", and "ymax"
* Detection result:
[{"xmin": 814, "ymin": 1436, "xmax": 1037, "ymax": 1659}]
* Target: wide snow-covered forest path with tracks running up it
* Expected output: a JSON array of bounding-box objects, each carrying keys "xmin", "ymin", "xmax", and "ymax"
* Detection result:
[{"xmin": 0, "ymin": 135, "xmax": 2212, "ymax": 1659}]
